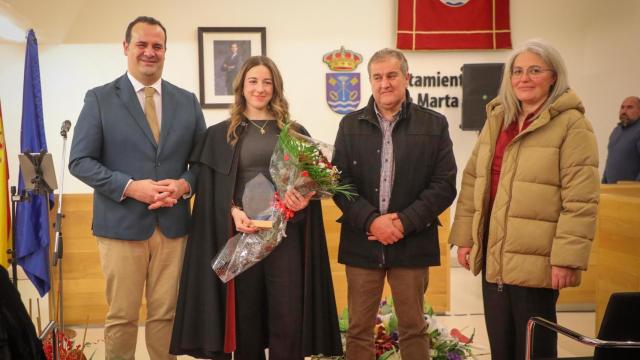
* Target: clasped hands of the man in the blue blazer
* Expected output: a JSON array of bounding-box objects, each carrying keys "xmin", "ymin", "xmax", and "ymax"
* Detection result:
[{"xmin": 124, "ymin": 179, "xmax": 191, "ymax": 210}]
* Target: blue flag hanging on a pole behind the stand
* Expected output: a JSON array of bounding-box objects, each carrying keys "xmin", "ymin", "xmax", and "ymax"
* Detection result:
[{"xmin": 15, "ymin": 30, "xmax": 53, "ymax": 296}]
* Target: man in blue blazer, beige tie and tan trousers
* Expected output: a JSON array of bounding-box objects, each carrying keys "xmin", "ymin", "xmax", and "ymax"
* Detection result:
[{"xmin": 69, "ymin": 17, "xmax": 206, "ymax": 359}]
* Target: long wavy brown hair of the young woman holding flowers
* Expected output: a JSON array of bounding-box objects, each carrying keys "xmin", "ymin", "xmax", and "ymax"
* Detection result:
[{"xmin": 227, "ymin": 56, "xmax": 289, "ymax": 145}]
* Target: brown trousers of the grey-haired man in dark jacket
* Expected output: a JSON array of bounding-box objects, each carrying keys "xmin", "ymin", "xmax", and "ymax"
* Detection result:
[{"xmin": 346, "ymin": 265, "xmax": 430, "ymax": 360}]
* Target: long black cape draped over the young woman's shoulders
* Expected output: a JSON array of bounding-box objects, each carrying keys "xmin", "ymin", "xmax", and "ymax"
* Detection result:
[{"xmin": 170, "ymin": 121, "xmax": 342, "ymax": 359}]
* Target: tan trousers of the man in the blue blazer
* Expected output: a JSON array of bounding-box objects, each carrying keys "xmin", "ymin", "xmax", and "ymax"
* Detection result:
[{"xmin": 96, "ymin": 228, "xmax": 186, "ymax": 360}]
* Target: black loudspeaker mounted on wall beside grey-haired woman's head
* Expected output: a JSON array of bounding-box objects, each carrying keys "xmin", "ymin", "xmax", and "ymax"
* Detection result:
[{"xmin": 460, "ymin": 63, "xmax": 504, "ymax": 130}]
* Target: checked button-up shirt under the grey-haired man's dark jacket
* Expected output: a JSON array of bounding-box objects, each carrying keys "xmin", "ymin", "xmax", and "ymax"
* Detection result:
[{"xmin": 374, "ymin": 104, "xmax": 400, "ymax": 214}]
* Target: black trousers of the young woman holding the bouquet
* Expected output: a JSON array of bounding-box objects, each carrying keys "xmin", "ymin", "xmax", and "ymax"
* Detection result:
[{"xmin": 234, "ymin": 222, "xmax": 304, "ymax": 360}]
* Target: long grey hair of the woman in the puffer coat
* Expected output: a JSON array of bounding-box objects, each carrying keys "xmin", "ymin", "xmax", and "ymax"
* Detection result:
[{"xmin": 498, "ymin": 39, "xmax": 569, "ymax": 128}]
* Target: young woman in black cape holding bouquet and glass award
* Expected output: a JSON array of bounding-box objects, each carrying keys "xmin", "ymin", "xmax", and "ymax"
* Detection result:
[{"xmin": 170, "ymin": 56, "xmax": 342, "ymax": 360}]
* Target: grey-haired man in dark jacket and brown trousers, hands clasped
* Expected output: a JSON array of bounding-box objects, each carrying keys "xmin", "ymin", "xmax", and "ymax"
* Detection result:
[{"xmin": 333, "ymin": 49, "xmax": 456, "ymax": 360}]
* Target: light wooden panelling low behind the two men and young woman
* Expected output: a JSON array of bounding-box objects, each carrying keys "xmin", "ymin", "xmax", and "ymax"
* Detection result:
[{"xmin": 50, "ymin": 194, "xmax": 450, "ymax": 325}]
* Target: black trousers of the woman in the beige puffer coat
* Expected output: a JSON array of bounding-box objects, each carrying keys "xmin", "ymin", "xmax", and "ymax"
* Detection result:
[{"xmin": 482, "ymin": 271, "xmax": 559, "ymax": 360}]
